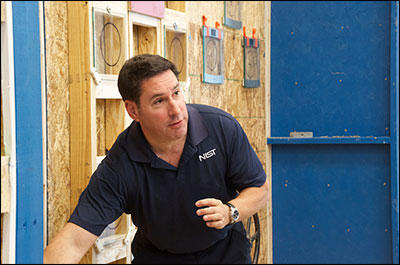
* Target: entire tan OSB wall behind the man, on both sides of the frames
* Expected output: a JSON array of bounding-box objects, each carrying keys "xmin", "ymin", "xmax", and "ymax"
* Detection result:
[{"xmin": 44, "ymin": 1, "xmax": 272, "ymax": 263}]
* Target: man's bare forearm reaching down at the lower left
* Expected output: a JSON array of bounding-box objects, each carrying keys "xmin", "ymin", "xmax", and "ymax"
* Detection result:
[{"xmin": 43, "ymin": 223, "xmax": 97, "ymax": 264}]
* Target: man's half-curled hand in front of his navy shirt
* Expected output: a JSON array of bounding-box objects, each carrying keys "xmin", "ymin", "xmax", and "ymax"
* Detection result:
[{"xmin": 195, "ymin": 198, "xmax": 230, "ymax": 229}]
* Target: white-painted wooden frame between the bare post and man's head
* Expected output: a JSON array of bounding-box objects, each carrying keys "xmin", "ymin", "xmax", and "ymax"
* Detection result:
[{"xmin": 91, "ymin": 1, "xmax": 136, "ymax": 264}]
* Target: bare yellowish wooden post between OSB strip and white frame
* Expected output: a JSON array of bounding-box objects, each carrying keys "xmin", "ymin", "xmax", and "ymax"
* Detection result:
[{"xmin": 67, "ymin": 1, "xmax": 92, "ymax": 263}]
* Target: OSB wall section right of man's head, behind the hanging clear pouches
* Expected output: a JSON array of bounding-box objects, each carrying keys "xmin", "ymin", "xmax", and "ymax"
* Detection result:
[{"xmin": 186, "ymin": 1, "xmax": 272, "ymax": 263}]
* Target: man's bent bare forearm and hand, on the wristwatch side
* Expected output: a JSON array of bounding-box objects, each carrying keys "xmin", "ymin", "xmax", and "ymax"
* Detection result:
[{"xmin": 196, "ymin": 178, "xmax": 269, "ymax": 229}]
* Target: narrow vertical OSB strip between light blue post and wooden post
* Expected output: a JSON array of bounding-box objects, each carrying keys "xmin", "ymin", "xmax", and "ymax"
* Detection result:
[{"xmin": 44, "ymin": 1, "xmax": 73, "ymax": 241}]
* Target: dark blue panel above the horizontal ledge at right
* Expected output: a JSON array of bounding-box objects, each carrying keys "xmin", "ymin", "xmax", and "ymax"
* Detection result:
[{"xmin": 271, "ymin": 1, "xmax": 390, "ymax": 137}]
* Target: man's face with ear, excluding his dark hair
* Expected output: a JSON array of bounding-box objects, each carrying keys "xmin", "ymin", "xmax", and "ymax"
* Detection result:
[{"xmin": 125, "ymin": 70, "xmax": 188, "ymax": 142}]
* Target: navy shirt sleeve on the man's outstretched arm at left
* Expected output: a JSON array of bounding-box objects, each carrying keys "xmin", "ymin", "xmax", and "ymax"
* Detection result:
[{"xmin": 68, "ymin": 160, "xmax": 126, "ymax": 236}]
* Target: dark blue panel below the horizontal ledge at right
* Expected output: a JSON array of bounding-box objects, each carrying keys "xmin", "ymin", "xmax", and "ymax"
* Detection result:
[{"xmin": 272, "ymin": 145, "xmax": 392, "ymax": 264}]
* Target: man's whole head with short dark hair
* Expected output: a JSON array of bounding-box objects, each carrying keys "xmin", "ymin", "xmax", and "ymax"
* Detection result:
[{"xmin": 118, "ymin": 55, "xmax": 188, "ymax": 144}]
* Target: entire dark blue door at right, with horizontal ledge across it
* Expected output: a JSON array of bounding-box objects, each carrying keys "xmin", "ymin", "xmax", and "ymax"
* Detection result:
[{"xmin": 267, "ymin": 1, "xmax": 399, "ymax": 263}]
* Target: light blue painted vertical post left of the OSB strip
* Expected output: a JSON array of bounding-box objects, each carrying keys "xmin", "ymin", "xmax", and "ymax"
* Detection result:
[{"xmin": 12, "ymin": 1, "xmax": 43, "ymax": 263}]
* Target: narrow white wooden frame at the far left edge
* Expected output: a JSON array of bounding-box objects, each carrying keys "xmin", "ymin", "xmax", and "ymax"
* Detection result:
[{"xmin": 1, "ymin": 1, "xmax": 17, "ymax": 264}]
